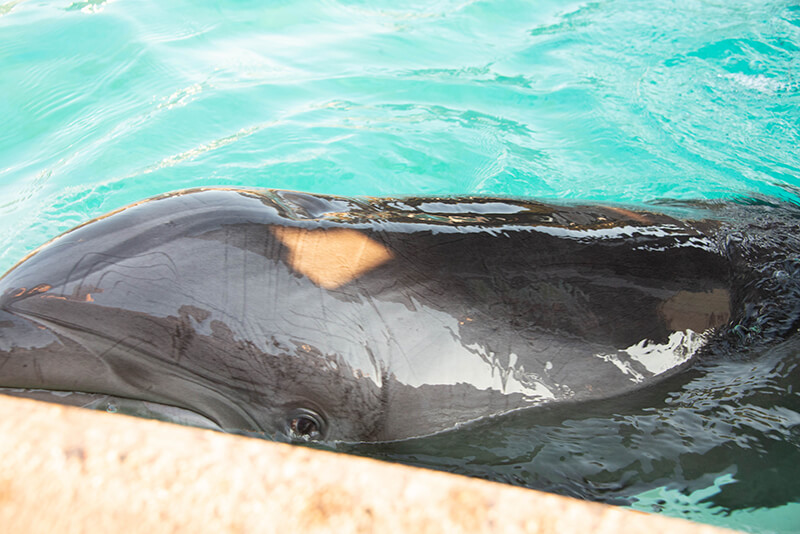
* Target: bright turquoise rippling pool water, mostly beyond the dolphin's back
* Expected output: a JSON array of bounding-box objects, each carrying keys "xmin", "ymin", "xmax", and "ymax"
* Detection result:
[{"xmin": 0, "ymin": 0, "xmax": 800, "ymax": 532}]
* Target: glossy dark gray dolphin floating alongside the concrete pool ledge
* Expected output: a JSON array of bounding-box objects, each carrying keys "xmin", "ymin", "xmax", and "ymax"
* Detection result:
[{"xmin": 0, "ymin": 188, "xmax": 735, "ymax": 441}]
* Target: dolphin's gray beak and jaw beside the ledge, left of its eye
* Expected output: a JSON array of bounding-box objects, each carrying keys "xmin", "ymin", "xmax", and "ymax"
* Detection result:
[{"xmin": 0, "ymin": 309, "xmax": 266, "ymax": 434}]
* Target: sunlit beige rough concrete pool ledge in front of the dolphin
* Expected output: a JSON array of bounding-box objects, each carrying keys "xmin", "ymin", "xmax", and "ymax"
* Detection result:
[{"xmin": 0, "ymin": 396, "xmax": 730, "ymax": 534}]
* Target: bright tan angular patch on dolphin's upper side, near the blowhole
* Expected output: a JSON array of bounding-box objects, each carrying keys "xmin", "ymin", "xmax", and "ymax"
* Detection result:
[{"xmin": 271, "ymin": 226, "xmax": 392, "ymax": 289}]
